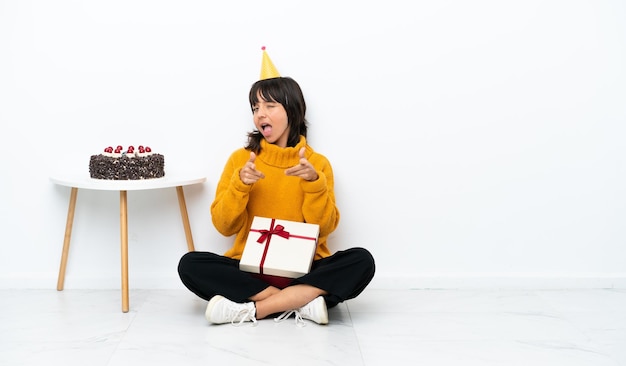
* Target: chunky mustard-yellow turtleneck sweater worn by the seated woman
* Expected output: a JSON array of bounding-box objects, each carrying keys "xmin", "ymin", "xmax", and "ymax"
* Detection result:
[{"xmin": 211, "ymin": 136, "xmax": 339, "ymax": 259}]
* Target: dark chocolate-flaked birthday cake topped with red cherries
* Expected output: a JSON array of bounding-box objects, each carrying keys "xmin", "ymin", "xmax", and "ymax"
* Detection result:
[{"xmin": 89, "ymin": 145, "xmax": 165, "ymax": 180}]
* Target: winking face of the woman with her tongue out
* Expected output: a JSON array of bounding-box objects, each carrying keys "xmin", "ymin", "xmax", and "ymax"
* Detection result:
[{"xmin": 252, "ymin": 94, "xmax": 289, "ymax": 147}]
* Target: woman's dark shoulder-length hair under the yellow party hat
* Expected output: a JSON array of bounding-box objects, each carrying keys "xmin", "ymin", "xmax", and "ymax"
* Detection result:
[{"xmin": 246, "ymin": 77, "xmax": 308, "ymax": 154}]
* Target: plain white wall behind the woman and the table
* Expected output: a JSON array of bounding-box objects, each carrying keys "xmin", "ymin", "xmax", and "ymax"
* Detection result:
[{"xmin": 0, "ymin": 0, "xmax": 626, "ymax": 288}]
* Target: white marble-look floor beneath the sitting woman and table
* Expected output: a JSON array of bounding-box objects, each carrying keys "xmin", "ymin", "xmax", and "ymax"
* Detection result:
[{"xmin": 0, "ymin": 289, "xmax": 626, "ymax": 366}]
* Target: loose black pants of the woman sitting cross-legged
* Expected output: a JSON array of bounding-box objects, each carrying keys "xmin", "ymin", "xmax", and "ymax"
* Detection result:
[{"xmin": 178, "ymin": 248, "xmax": 376, "ymax": 308}]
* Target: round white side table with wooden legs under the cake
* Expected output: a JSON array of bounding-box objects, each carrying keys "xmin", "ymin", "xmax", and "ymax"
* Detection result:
[{"xmin": 50, "ymin": 171, "xmax": 206, "ymax": 313}]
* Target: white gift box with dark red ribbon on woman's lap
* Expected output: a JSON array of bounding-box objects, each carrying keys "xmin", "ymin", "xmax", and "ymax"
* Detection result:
[{"xmin": 239, "ymin": 216, "xmax": 320, "ymax": 278}]
